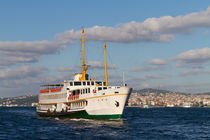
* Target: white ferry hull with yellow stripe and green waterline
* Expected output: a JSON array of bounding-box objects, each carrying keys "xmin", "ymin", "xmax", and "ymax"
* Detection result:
[{"xmin": 37, "ymin": 87, "xmax": 131, "ymax": 119}]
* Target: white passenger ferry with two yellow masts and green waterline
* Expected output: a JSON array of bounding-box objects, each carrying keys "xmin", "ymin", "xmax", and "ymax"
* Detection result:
[{"xmin": 36, "ymin": 28, "xmax": 132, "ymax": 119}]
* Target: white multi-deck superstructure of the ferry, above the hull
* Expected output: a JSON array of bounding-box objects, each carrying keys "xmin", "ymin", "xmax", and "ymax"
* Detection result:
[{"xmin": 39, "ymin": 80, "xmax": 122, "ymax": 112}]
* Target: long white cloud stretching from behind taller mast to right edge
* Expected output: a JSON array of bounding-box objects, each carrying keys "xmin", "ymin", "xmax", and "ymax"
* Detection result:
[{"xmin": 55, "ymin": 7, "xmax": 210, "ymax": 43}]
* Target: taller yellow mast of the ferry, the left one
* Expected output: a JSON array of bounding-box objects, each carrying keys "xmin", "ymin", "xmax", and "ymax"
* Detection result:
[{"xmin": 81, "ymin": 28, "xmax": 87, "ymax": 80}]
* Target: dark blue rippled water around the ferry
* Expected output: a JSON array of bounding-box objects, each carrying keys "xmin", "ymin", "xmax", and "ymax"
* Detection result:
[{"xmin": 0, "ymin": 107, "xmax": 210, "ymax": 140}]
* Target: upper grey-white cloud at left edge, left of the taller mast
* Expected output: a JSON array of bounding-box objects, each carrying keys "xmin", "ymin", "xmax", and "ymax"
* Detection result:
[{"xmin": 0, "ymin": 41, "xmax": 66, "ymax": 68}]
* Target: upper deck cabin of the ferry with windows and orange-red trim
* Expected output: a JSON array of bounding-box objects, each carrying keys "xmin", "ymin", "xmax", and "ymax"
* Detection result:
[{"xmin": 40, "ymin": 75, "xmax": 123, "ymax": 100}]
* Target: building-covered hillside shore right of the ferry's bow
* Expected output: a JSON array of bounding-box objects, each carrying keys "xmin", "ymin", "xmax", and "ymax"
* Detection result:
[{"xmin": 128, "ymin": 89, "xmax": 210, "ymax": 108}]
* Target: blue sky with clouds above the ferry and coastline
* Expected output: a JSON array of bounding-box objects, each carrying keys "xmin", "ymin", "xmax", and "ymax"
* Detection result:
[{"xmin": 0, "ymin": 0, "xmax": 210, "ymax": 97}]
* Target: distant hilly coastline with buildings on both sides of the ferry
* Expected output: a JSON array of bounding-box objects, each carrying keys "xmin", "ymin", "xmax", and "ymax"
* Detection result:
[{"xmin": 0, "ymin": 89, "xmax": 210, "ymax": 108}]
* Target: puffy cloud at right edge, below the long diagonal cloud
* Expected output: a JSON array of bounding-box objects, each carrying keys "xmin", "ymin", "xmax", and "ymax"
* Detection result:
[{"xmin": 175, "ymin": 48, "xmax": 210, "ymax": 67}]
